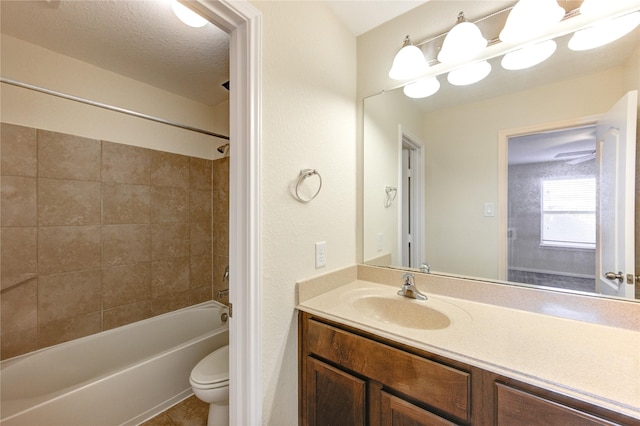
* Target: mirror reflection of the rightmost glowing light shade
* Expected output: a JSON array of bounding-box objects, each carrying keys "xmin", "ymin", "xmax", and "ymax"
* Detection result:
[{"xmin": 569, "ymin": 12, "xmax": 640, "ymax": 50}]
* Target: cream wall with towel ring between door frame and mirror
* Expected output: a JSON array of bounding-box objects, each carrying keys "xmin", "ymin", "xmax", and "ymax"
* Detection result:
[{"xmin": 253, "ymin": 1, "xmax": 356, "ymax": 425}]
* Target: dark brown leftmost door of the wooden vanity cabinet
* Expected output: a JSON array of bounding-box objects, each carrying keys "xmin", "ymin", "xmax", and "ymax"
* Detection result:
[{"xmin": 305, "ymin": 357, "xmax": 366, "ymax": 426}]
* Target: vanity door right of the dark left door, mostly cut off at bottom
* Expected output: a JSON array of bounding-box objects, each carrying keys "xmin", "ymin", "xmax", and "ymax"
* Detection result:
[{"xmin": 380, "ymin": 391, "xmax": 454, "ymax": 426}]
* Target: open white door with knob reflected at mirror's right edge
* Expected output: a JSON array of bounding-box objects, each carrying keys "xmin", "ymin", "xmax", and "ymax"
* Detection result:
[{"xmin": 596, "ymin": 90, "xmax": 638, "ymax": 298}]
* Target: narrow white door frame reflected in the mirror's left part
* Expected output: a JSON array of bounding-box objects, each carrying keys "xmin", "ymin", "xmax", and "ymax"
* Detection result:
[{"xmin": 398, "ymin": 125, "xmax": 425, "ymax": 268}]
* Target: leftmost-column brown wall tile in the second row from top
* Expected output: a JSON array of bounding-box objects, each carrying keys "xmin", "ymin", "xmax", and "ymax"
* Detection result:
[{"xmin": 0, "ymin": 176, "xmax": 38, "ymax": 226}]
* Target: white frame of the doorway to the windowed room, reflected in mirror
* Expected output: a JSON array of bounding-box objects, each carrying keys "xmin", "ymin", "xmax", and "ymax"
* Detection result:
[{"xmin": 497, "ymin": 114, "xmax": 603, "ymax": 281}]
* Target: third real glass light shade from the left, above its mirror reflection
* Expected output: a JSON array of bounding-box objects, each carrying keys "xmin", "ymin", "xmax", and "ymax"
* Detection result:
[{"xmin": 500, "ymin": 0, "xmax": 564, "ymax": 43}]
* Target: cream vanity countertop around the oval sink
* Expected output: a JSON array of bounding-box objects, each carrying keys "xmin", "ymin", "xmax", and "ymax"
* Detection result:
[{"xmin": 297, "ymin": 280, "xmax": 640, "ymax": 419}]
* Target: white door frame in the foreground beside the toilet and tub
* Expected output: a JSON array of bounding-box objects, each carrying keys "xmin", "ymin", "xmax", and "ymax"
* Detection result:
[{"xmin": 190, "ymin": 0, "xmax": 262, "ymax": 425}]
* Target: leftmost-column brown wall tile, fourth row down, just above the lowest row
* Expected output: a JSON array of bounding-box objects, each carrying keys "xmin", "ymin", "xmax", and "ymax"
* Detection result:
[{"xmin": 0, "ymin": 278, "xmax": 38, "ymax": 336}]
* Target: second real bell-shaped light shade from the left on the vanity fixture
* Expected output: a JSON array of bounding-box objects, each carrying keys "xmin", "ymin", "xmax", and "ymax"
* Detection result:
[{"xmin": 438, "ymin": 12, "xmax": 487, "ymax": 64}]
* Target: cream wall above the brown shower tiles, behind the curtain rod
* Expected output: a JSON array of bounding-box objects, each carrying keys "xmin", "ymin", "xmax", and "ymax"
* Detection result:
[{"xmin": 0, "ymin": 34, "xmax": 229, "ymax": 159}]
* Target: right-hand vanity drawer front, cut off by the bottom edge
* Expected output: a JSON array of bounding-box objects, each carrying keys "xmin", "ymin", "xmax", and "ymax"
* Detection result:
[{"xmin": 496, "ymin": 383, "xmax": 618, "ymax": 426}]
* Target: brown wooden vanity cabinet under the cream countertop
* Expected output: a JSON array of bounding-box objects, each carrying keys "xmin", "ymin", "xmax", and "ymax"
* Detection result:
[{"xmin": 298, "ymin": 312, "xmax": 640, "ymax": 426}]
